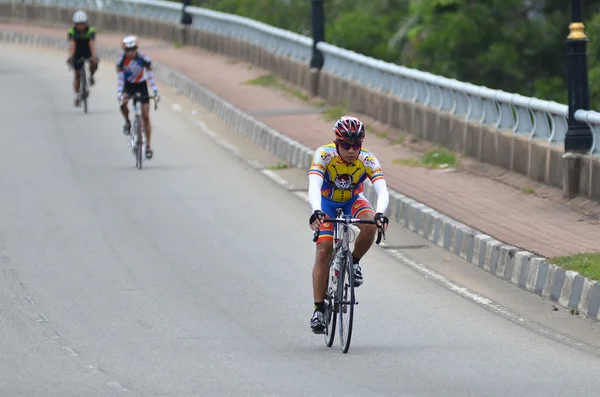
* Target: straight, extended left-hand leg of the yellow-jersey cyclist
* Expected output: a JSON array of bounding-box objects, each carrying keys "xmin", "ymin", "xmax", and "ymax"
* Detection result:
[{"xmin": 310, "ymin": 199, "xmax": 335, "ymax": 332}]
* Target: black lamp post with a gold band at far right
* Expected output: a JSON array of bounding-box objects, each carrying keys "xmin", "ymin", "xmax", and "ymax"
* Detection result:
[{"xmin": 565, "ymin": 0, "xmax": 593, "ymax": 153}]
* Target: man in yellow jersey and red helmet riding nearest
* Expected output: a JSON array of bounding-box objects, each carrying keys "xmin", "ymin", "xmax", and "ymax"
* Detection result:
[{"xmin": 308, "ymin": 116, "xmax": 389, "ymax": 333}]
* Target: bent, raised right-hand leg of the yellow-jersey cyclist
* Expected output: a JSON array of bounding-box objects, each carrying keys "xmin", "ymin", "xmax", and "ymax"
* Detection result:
[{"xmin": 352, "ymin": 194, "xmax": 377, "ymax": 287}]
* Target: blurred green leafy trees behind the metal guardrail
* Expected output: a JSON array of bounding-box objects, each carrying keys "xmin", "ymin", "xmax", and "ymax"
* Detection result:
[{"xmin": 193, "ymin": 0, "xmax": 600, "ymax": 107}]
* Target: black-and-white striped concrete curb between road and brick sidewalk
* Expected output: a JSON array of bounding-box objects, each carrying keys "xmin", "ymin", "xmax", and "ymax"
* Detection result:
[{"xmin": 0, "ymin": 32, "xmax": 600, "ymax": 319}]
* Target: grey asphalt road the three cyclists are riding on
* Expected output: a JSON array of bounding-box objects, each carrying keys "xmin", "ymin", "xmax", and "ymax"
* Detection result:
[{"xmin": 0, "ymin": 44, "xmax": 600, "ymax": 397}]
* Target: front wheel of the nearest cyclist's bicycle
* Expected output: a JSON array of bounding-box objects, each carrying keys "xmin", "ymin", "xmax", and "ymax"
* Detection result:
[{"xmin": 337, "ymin": 253, "xmax": 355, "ymax": 353}]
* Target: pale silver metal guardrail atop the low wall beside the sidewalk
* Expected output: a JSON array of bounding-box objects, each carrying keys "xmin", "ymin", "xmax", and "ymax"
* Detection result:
[{"xmin": 8, "ymin": 0, "xmax": 600, "ymax": 154}]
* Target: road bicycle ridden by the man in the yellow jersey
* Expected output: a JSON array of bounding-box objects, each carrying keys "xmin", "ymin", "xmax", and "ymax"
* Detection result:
[{"xmin": 313, "ymin": 208, "xmax": 385, "ymax": 353}]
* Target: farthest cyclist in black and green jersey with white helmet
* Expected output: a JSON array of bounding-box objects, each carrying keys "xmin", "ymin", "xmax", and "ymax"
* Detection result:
[{"xmin": 67, "ymin": 10, "xmax": 99, "ymax": 106}]
